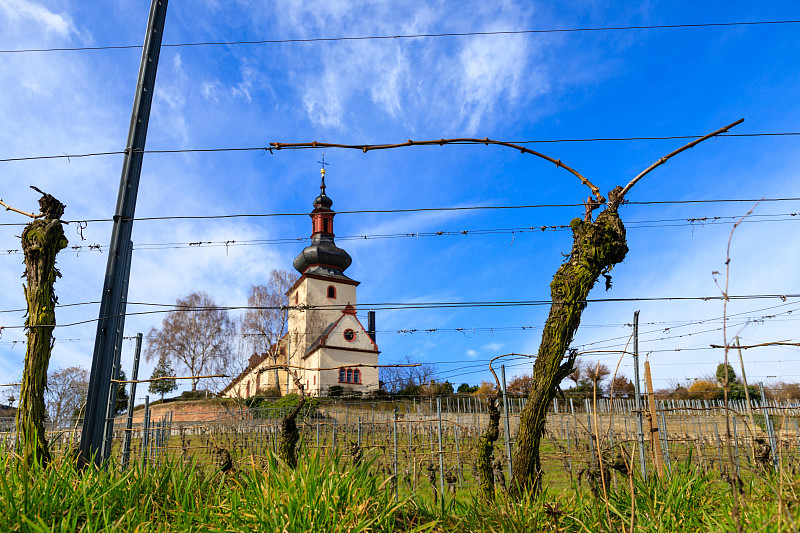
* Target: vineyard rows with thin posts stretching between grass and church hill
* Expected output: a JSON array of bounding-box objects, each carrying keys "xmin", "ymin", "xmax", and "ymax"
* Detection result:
[{"xmin": 0, "ymin": 390, "xmax": 800, "ymax": 492}]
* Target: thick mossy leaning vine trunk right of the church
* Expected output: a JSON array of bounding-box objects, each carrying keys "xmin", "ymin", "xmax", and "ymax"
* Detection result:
[{"xmin": 510, "ymin": 201, "xmax": 628, "ymax": 496}]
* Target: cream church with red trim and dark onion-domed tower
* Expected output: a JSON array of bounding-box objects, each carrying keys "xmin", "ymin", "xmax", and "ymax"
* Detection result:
[{"xmin": 222, "ymin": 168, "xmax": 380, "ymax": 398}]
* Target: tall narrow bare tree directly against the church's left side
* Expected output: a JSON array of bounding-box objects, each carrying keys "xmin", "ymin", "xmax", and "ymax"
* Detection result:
[{"xmin": 241, "ymin": 269, "xmax": 297, "ymax": 387}]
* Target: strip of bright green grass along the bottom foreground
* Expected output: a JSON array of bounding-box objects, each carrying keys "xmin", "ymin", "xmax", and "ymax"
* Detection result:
[{"xmin": 0, "ymin": 455, "xmax": 800, "ymax": 533}]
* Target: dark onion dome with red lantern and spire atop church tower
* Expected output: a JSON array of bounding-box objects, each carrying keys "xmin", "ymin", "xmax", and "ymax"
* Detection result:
[{"xmin": 293, "ymin": 168, "xmax": 353, "ymax": 277}]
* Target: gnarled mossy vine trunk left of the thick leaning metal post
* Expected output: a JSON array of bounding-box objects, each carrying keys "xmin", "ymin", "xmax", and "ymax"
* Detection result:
[{"xmin": 17, "ymin": 194, "xmax": 68, "ymax": 464}]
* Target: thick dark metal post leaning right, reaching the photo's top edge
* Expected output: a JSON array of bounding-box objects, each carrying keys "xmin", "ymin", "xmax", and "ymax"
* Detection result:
[{"xmin": 80, "ymin": 0, "xmax": 167, "ymax": 465}]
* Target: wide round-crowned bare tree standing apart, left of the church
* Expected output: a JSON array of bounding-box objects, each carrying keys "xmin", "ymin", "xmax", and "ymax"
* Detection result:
[{"xmin": 145, "ymin": 292, "xmax": 236, "ymax": 392}]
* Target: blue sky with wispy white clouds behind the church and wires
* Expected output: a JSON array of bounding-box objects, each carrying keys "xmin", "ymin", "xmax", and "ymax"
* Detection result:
[{"xmin": 0, "ymin": 0, "xmax": 800, "ymax": 401}]
